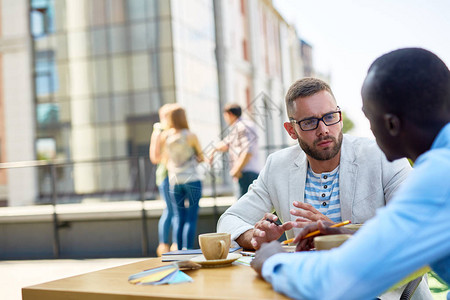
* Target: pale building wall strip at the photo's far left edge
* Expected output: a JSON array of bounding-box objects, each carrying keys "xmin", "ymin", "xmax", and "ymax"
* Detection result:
[{"xmin": 0, "ymin": 0, "xmax": 37, "ymax": 206}]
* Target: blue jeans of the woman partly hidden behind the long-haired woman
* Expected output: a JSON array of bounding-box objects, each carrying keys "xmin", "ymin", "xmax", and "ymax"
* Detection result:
[{"xmin": 158, "ymin": 177, "xmax": 177, "ymax": 244}]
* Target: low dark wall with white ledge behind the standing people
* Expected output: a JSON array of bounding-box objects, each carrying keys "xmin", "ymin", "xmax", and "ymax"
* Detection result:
[{"xmin": 0, "ymin": 197, "xmax": 234, "ymax": 259}]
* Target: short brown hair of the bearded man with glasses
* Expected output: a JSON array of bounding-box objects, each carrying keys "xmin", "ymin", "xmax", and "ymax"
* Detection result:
[{"xmin": 285, "ymin": 77, "xmax": 334, "ymax": 117}]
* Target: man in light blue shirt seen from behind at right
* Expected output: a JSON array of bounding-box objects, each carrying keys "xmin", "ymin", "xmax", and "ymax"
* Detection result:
[{"xmin": 252, "ymin": 48, "xmax": 450, "ymax": 299}]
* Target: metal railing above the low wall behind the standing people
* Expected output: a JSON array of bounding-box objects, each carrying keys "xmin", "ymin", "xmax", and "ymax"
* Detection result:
[{"xmin": 0, "ymin": 156, "xmax": 231, "ymax": 258}]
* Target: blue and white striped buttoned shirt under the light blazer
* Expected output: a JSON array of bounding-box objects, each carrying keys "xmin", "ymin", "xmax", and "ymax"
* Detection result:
[{"xmin": 305, "ymin": 166, "xmax": 342, "ymax": 222}]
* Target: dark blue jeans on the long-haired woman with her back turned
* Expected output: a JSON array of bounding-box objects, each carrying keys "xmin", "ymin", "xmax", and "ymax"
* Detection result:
[{"xmin": 172, "ymin": 181, "xmax": 202, "ymax": 249}]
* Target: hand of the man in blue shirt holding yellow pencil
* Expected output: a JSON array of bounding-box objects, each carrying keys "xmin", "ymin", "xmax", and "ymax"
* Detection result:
[{"xmin": 293, "ymin": 221, "xmax": 355, "ymax": 251}]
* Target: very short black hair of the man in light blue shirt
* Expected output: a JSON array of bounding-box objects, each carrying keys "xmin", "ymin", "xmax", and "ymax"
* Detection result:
[{"xmin": 368, "ymin": 48, "xmax": 450, "ymax": 123}]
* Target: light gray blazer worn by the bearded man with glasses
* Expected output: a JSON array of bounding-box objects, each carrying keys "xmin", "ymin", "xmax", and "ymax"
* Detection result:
[{"xmin": 217, "ymin": 135, "xmax": 411, "ymax": 240}]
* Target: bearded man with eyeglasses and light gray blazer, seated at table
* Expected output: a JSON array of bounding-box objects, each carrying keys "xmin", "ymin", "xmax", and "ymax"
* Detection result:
[{"xmin": 217, "ymin": 78, "xmax": 432, "ymax": 299}]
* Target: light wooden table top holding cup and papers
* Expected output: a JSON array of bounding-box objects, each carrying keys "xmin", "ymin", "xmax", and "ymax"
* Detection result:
[{"xmin": 22, "ymin": 258, "xmax": 288, "ymax": 300}]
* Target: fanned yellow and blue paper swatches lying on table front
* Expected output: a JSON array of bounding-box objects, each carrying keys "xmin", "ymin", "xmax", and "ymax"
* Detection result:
[{"xmin": 128, "ymin": 265, "xmax": 192, "ymax": 285}]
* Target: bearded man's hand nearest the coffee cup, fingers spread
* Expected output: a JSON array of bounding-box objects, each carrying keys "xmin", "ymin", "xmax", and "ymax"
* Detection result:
[{"xmin": 251, "ymin": 213, "xmax": 297, "ymax": 249}]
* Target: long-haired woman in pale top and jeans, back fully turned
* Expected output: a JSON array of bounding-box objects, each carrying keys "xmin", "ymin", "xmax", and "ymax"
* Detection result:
[{"xmin": 156, "ymin": 107, "xmax": 203, "ymax": 249}]
